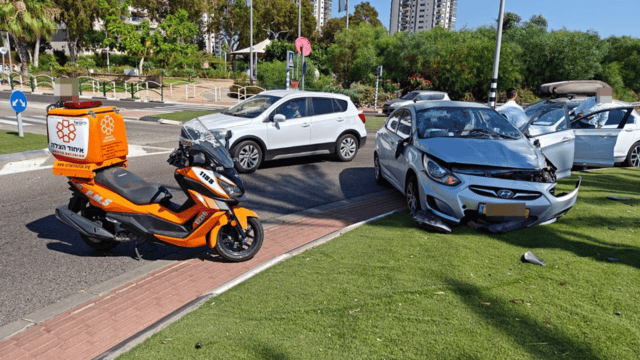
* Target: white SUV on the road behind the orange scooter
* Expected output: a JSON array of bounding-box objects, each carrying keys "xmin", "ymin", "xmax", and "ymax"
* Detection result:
[{"xmin": 190, "ymin": 90, "xmax": 367, "ymax": 173}]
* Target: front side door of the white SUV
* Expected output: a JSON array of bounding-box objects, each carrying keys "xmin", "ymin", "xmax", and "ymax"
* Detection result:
[{"xmin": 267, "ymin": 97, "xmax": 311, "ymax": 156}]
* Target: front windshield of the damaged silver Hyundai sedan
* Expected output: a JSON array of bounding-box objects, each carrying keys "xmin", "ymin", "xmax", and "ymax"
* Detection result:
[{"xmin": 416, "ymin": 107, "xmax": 522, "ymax": 139}]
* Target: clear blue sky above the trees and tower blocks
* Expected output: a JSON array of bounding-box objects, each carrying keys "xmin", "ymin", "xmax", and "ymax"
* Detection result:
[{"xmin": 332, "ymin": 0, "xmax": 640, "ymax": 38}]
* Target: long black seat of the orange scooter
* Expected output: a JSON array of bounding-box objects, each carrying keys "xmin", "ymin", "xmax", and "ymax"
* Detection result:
[{"xmin": 94, "ymin": 167, "xmax": 171, "ymax": 205}]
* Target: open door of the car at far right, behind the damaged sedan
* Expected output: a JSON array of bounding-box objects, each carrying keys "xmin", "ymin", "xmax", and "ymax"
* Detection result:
[{"xmin": 571, "ymin": 107, "xmax": 633, "ymax": 167}]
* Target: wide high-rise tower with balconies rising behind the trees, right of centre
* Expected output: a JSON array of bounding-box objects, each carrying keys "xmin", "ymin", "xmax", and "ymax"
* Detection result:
[{"xmin": 389, "ymin": 0, "xmax": 458, "ymax": 34}]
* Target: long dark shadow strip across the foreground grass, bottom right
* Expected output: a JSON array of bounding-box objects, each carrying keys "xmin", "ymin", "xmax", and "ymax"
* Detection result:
[{"xmin": 443, "ymin": 277, "xmax": 601, "ymax": 359}]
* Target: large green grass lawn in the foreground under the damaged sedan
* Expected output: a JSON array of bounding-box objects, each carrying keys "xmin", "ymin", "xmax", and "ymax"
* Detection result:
[{"xmin": 122, "ymin": 168, "xmax": 640, "ymax": 359}]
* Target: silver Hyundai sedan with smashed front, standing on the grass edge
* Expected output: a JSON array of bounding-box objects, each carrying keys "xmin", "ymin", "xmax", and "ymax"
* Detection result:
[{"xmin": 374, "ymin": 101, "xmax": 581, "ymax": 233}]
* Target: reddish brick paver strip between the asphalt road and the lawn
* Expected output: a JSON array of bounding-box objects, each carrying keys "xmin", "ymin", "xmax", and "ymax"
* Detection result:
[{"xmin": 0, "ymin": 192, "xmax": 404, "ymax": 360}]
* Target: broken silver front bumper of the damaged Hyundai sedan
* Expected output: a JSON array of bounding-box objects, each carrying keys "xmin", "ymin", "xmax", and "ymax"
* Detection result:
[{"xmin": 418, "ymin": 172, "xmax": 582, "ymax": 232}]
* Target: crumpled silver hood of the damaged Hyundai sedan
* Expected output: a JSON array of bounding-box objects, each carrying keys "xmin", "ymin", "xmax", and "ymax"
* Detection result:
[{"xmin": 416, "ymin": 137, "xmax": 545, "ymax": 170}]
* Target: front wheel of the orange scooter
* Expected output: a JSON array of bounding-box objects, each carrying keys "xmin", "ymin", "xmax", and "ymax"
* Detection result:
[{"xmin": 216, "ymin": 217, "xmax": 264, "ymax": 262}]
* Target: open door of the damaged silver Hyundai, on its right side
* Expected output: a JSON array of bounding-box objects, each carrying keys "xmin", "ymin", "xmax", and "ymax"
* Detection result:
[{"xmin": 522, "ymin": 104, "xmax": 575, "ymax": 179}]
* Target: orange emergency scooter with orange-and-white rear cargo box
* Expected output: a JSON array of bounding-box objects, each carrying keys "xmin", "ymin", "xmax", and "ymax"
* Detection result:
[{"xmin": 47, "ymin": 104, "xmax": 264, "ymax": 261}]
